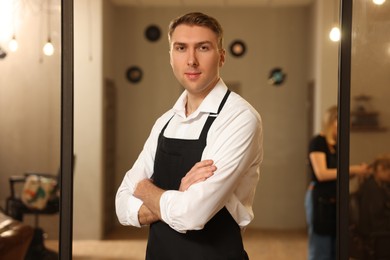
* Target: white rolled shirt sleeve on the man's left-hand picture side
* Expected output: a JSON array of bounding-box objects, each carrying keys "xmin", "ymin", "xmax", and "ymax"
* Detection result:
[{"xmin": 115, "ymin": 112, "xmax": 172, "ymax": 227}]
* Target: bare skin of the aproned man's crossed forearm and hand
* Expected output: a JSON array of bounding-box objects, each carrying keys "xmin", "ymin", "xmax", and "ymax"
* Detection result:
[{"xmin": 134, "ymin": 160, "xmax": 217, "ymax": 225}]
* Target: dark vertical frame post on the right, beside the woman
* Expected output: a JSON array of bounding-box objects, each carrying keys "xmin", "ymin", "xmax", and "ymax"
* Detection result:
[{"xmin": 337, "ymin": 0, "xmax": 352, "ymax": 260}]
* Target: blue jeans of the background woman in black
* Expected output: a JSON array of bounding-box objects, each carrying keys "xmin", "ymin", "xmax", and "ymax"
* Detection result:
[{"xmin": 305, "ymin": 189, "xmax": 336, "ymax": 260}]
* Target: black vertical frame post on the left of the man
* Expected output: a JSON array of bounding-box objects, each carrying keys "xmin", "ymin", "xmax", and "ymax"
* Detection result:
[{"xmin": 59, "ymin": 0, "xmax": 74, "ymax": 260}]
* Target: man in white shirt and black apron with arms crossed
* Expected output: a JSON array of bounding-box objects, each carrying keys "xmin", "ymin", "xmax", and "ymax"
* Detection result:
[{"xmin": 116, "ymin": 13, "xmax": 263, "ymax": 260}]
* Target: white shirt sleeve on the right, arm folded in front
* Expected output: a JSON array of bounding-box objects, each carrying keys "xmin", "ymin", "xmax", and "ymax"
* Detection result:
[{"xmin": 160, "ymin": 104, "xmax": 263, "ymax": 232}]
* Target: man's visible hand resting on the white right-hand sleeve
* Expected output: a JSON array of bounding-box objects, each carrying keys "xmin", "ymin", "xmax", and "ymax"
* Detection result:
[{"xmin": 179, "ymin": 160, "xmax": 217, "ymax": 191}]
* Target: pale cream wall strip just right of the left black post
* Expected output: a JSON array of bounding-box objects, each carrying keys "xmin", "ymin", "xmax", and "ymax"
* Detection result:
[{"xmin": 73, "ymin": 0, "xmax": 104, "ymax": 239}]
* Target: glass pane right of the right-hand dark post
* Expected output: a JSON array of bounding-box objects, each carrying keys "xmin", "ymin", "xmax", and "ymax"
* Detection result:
[{"xmin": 350, "ymin": 0, "xmax": 390, "ymax": 259}]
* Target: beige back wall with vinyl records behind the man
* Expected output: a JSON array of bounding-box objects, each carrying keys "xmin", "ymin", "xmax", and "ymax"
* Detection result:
[{"xmin": 109, "ymin": 7, "xmax": 310, "ymax": 229}]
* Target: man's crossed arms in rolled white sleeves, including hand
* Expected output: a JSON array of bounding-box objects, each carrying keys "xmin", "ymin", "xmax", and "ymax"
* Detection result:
[{"xmin": 115, "ymin": 103, "xmax": 262, "ymax": 232}]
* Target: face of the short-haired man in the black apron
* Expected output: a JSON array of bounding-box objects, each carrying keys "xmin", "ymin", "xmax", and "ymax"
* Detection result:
[{"xmin": 170, "ymin": 24, "xmax": 225, "ymax": 96}]
